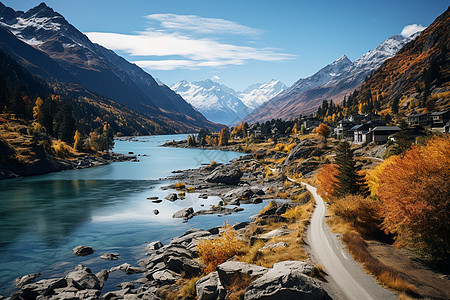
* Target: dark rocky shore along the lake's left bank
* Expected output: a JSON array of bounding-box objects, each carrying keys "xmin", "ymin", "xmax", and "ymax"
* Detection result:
[{"xmin": 0, "ymin": 153, "xmax": 137, "ymax": 180}]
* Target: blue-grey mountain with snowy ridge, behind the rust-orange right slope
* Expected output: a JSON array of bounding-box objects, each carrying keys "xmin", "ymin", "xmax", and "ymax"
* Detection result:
[{"xmin": 243, "ymin": 35, "xmax": 410, "ymax": 123}]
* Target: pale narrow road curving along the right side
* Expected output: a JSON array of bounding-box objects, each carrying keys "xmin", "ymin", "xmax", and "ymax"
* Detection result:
[{"xmin": 302, "ymin": 182, "xmax": 397, "ymax": 300}]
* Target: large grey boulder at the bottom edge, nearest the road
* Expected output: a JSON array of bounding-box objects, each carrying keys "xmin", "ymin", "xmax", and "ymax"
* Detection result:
[{"xmin": 244, "ymin": 261, "xmax": 331, "ymax": 300}]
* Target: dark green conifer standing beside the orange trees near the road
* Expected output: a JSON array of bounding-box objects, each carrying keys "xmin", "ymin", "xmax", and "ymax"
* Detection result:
[{"xmin": 335, "ymin": 142, "xmax": 366, "ymax": 197}]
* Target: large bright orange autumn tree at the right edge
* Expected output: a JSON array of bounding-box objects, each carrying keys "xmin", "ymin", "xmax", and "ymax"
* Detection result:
[{"xmin": 369, "ymin": 135, "xmax": 450, "ymax": 263}]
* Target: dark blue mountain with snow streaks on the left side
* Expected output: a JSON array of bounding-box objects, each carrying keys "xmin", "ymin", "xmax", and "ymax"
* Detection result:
[{"xmin": 0, "ymin": 3, "xmax": 220, "ymax": 132}]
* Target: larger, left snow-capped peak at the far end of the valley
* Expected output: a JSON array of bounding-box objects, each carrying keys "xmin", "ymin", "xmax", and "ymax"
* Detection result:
[{"xmin": 171, "ymin": 79, "xmax": 251, "ymax": 125}]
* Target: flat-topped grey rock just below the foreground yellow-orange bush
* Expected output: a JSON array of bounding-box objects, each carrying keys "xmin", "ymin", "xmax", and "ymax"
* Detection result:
[{"xmin": 217, "ymin": 261, "xmax": 268, "ymax": 288}]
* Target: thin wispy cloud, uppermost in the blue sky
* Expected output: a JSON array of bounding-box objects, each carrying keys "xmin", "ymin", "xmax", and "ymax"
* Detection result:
[{"xmin": 146, "ymin": 14, "xmax": 262, "ymax": 36}]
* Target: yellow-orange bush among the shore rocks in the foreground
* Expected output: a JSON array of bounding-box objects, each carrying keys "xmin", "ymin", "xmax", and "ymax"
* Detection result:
[{"xmin": 197, "ymin": 223, "xmax": 244, "ymax": 274}]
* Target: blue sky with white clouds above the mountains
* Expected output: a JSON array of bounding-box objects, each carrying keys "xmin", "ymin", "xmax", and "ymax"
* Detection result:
[{"xmin": 0, "ymin": 0, "xmax": 449, "ymax": 91}]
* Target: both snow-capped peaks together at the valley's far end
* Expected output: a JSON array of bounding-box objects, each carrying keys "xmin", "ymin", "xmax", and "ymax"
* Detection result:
[{"xmin": 171, "ymin": 79, "xmax": 287, "ymax": 125}]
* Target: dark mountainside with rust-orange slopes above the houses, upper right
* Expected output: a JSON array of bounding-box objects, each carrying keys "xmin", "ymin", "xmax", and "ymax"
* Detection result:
[{"xmin": 354, "ymin": 8, "xmax": 450, "ymax": 112}]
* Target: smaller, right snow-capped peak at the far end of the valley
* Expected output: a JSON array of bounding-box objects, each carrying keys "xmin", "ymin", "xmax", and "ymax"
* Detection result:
[{"xmin": 239, "ymin": 79, "xmax": 287, "ymax": 109}]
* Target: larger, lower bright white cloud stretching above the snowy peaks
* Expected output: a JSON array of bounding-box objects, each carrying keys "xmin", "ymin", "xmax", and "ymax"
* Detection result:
[{"xmin": 85, "ymin": 29, "xmax": 295, "ymax": 70}]
